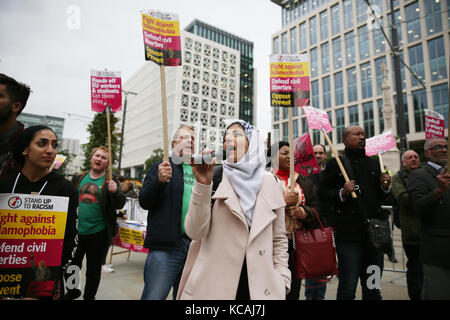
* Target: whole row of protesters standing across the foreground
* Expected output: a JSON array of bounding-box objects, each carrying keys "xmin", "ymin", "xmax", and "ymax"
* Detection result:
[{"xmin": 0, "ymin": 70, "xmax": 450, "ymax": 300}]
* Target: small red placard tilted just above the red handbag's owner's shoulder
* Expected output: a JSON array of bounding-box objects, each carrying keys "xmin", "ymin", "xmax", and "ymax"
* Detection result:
[{"xmin": 294, "ymin": 132, "xmax": 320, "ymax": 176}]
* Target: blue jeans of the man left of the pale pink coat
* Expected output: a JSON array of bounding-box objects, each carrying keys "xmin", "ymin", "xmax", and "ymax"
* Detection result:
[{"xmin": 141, "ymin": 238, "xmax": 190, "ymax": 300}]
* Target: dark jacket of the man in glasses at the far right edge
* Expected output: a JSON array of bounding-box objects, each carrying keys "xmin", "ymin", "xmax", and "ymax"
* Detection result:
[{"xmin": 408, "ymin": 163, "xmax": 450, "ymax": 268}]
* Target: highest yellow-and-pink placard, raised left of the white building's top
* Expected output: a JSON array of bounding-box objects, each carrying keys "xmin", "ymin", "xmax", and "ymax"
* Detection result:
[{"xmin": 142, "ymin": 10, "xmax": 181, "ymax": 66}]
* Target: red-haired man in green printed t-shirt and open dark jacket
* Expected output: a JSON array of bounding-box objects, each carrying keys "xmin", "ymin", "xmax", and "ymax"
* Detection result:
[{"xmin": 66, "ymin": 146, "xmax": 126, "ymax": 300}]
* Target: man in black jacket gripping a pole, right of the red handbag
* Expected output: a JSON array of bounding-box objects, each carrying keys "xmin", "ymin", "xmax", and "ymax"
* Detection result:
[{"xmin": 319, "ymin": 126, "xmax": 391, "ymax": 300}]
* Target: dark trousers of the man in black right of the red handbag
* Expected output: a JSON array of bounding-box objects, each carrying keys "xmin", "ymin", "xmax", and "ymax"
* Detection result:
[{"xmin": 336, "ymin": 241, "xmax": 384, "ymax": 300}]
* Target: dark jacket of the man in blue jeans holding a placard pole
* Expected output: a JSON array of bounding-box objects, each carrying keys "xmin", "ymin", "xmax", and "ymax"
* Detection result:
[{"xmin": 139, "ymin": 159, "xmax": 184, "ymax": 250}]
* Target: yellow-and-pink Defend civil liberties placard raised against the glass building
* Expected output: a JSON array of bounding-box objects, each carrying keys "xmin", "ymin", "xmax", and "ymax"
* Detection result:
[{"xmin": 270, "ymin": 54, "xmax": 310, "ymax": 107}]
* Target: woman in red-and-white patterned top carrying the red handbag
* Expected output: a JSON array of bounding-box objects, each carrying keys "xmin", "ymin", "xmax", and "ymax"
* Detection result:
[{"xmin": 267, "ymin": 141, "xmax": 319, "ymax": 300}]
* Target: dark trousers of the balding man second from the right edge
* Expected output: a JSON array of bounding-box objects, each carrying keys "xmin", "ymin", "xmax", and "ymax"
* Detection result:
[{"xmin": 403, "ymin": 243, "xmax": 423, "ymax": 300}]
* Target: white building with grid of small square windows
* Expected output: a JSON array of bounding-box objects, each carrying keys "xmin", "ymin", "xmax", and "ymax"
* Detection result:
[{"xmin": 118, "ymin": 30, "xmax": 241, "ymax": 179}]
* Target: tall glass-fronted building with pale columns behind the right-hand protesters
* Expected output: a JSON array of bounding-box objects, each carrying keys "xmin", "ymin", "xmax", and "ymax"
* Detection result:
[{"xmin": 271, "ymin": 0, "xmax": 450, "ymax": 150}]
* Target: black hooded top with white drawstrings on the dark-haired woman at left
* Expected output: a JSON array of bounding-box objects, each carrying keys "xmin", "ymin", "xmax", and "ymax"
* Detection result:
[{"xmin": 0, "ymin": 172, "xmax": 78, "ymax": 268}]
